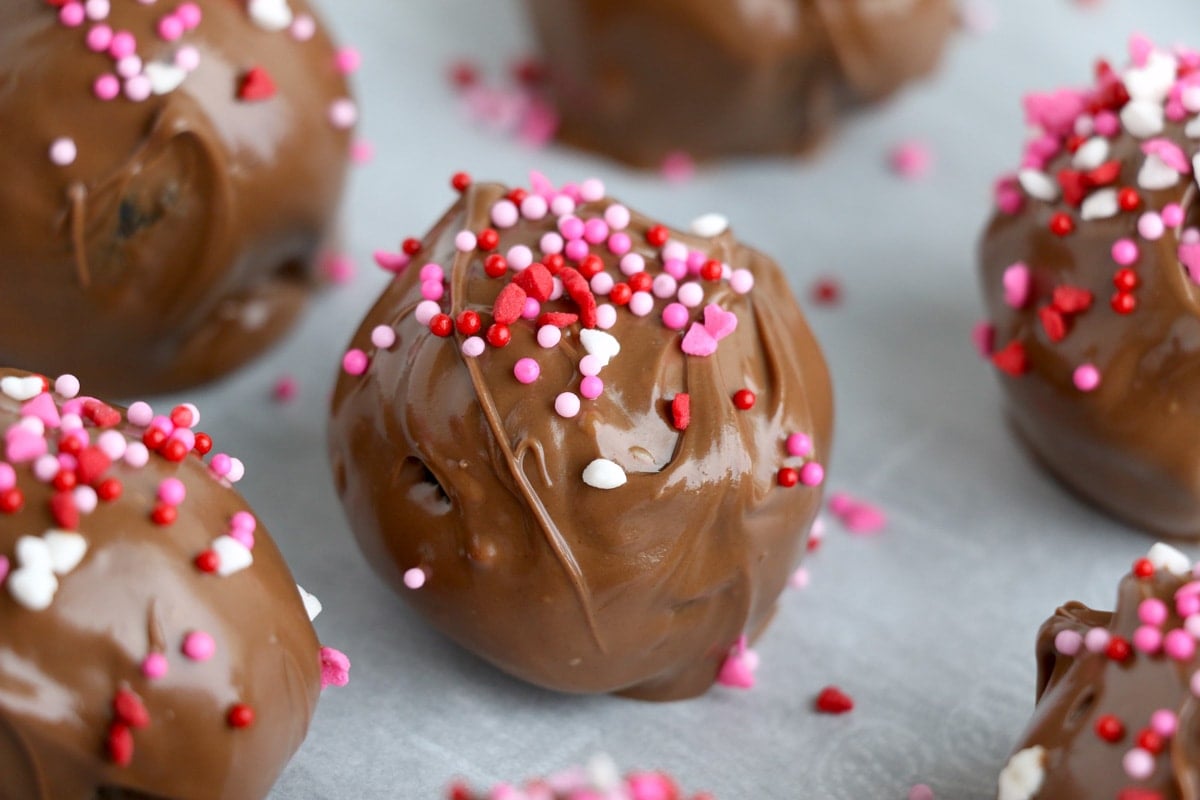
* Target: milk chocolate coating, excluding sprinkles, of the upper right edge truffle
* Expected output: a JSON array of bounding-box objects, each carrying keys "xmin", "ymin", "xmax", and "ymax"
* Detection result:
[{"xmin": 979, "ymin": 51, "xmax": 1200, "ymax": 539}]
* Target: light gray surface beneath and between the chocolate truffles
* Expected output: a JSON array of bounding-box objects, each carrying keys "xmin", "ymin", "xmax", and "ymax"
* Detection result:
[{"xmin": 152, "ymin": 0, "xmax": 1200, "ymax": 800}]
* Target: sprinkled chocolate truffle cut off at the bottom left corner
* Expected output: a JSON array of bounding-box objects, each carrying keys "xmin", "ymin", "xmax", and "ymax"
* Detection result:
[{"xmin": 0, "ymin": 369, "xmax": 349, "ymax": 800}]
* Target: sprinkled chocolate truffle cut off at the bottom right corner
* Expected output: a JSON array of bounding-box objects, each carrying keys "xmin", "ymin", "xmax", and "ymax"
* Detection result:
[{"xmin": 1000, "ymin": 545, "xmax": 1200, "ymax": 800}]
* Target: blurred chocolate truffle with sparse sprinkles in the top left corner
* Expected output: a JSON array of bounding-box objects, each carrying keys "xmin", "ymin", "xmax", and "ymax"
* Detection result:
[{"xmin": 0, "ymin": 0, "xmax": 355, "ymax": 396}]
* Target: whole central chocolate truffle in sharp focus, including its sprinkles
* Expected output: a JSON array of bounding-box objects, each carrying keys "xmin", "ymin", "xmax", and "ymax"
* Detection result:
[{"xmin": 330, "ymin": 174, "xmax": 832, "ymax": 700}]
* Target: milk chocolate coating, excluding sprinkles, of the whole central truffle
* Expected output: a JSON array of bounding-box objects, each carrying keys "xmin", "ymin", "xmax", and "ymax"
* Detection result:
[{"xmin": 329, "ymin": 179, "xmax": 832, "ymax": 700}]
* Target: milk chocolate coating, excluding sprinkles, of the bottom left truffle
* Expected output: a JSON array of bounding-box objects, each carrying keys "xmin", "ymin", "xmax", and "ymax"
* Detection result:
[{"xmin": 0, "ymin": 369, "xmax": 320, "ymax": 800}]
